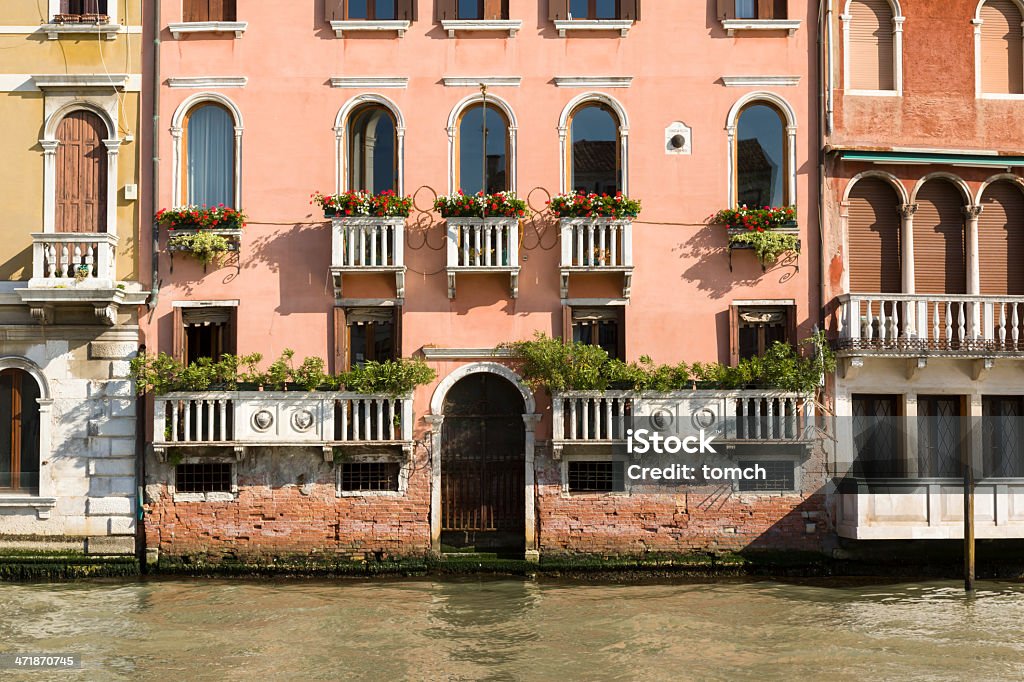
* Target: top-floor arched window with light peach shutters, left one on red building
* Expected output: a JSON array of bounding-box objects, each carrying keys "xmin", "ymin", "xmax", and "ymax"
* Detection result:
[{"xmin": 847, "ymin": 0, "xmax": 896, "ymax": 90}]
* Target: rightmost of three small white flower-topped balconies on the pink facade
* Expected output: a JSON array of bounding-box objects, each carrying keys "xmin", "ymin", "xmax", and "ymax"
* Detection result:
[{"xmin": 559, "ymin": 218, "xmax": 633, "ymax": 299}]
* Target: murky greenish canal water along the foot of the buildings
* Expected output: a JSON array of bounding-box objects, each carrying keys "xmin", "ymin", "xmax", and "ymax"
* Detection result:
[{"xmin": 0, "ymin": 580, "xmax": 1024, "ymax": 682}]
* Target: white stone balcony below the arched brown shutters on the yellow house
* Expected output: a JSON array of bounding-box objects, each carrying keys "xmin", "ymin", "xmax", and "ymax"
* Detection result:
[{"xmin": 17, "ymin": 232, "xmax": 134, "ymax": 325}]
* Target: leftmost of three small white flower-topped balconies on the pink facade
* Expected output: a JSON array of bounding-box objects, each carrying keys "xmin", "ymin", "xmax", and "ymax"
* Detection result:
[{"xmin": 331, "ymin": 217, "xmax": 406, "ymax": 298}]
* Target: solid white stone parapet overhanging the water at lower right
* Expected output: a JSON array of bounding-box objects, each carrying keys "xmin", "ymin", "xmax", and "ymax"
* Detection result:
[{"xmin": 837, "ymin": 478, "xmax": 1024, "ymax": 540}]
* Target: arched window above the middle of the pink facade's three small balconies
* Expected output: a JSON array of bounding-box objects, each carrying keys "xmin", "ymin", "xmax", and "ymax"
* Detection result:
[{"xmin": 456, "ymin": 103, "xmax": 512, "ymax": 195}]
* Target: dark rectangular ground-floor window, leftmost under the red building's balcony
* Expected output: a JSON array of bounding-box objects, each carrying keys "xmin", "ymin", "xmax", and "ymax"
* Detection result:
[{"xmin": 852, "ymin": 394, "xmax": 906, "ymax": 478}]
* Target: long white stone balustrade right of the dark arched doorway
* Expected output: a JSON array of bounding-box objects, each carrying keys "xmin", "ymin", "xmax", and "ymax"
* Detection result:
[{"xmin": 552, "ymin": 390, "xmax": 815, "ymax": 459}]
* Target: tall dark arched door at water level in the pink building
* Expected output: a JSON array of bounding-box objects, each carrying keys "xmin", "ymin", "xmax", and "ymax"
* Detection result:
[{"xmin": 441, "ymin": 373, "xmax": 525, "ymax": 551}]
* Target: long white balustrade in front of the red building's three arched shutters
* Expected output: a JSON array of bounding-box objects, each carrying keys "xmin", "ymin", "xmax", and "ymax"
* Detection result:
[{"xmin": 838, "ymin": 294, "xmax": 1024, "ymax": 355}]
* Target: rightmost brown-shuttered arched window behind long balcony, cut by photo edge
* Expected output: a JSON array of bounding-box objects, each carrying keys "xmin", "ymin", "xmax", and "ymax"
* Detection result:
[{"xmin": 978, "ymin": 181, "xmax": 1024, "ymax": 296}]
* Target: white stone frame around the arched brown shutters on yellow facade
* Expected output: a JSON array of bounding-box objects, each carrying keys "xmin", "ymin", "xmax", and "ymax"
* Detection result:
[{"xmin": 33, "ymin": 75, "xmax": 128, "ymax": 238}]
